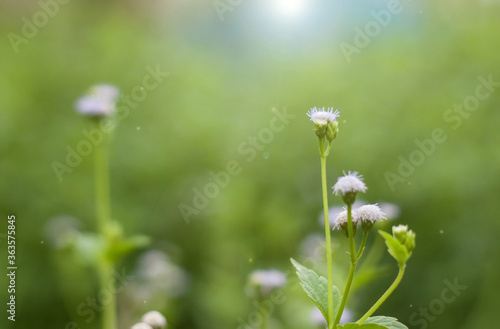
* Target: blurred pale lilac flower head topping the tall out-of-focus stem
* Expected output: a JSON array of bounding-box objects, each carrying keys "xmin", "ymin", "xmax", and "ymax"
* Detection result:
[{"xmin": 76, "ymin": 84, "xmax": 120, "ymax": 117}]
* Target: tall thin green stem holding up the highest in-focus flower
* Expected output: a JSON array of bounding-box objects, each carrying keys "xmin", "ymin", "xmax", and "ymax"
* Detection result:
[{"xmin": 320, "ymin": 154, "xmax": 333, "ymax": 329}]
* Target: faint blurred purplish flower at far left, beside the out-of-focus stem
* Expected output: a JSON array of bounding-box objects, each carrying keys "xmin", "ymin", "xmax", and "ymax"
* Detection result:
[{"xmin": 44, "ymin": 215, "xmax": 81, "ymax": 249}]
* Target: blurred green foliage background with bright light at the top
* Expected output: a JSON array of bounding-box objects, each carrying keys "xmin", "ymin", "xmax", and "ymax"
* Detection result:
[{"xmin": 0, "ymin": 0, "xmax": 500, "ymax": 329}]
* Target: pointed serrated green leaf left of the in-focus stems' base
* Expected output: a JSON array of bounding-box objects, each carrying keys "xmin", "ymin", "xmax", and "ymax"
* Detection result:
[{"xmin": 290, "ymin": 258, "xmax": 341, "ymax": 322}]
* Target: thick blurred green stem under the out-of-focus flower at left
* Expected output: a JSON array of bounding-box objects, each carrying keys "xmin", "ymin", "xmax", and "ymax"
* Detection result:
[{"xmin": 94, "ymin": 130, "xmax": 116, "ymax": 329}]
